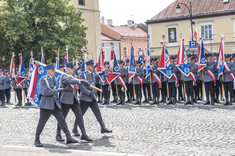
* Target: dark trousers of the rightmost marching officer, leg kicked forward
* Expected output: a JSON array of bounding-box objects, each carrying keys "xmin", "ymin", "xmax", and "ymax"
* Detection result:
[{"xmin": 80, "ymin": 99, "xmax": 105, "ymax": 128}]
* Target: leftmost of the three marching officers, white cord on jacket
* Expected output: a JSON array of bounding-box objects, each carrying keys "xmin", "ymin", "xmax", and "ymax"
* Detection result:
[{"xmin": 34, "ymin": 64, "xmax": 78, "ymax": 147}]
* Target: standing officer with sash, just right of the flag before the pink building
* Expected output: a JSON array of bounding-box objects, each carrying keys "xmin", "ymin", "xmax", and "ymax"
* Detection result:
[{"xmin": 133, "ymin": 60, "xmax": 143, "ymax": 105}]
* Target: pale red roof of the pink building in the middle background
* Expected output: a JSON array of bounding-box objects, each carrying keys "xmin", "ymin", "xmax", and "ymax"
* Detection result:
[{"xmin": 106, "ymin": 25, "xmax": 147, "ymax": 38}]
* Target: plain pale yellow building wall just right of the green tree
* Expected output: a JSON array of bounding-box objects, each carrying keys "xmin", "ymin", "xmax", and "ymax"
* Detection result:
[{"xmin": 70, "ymin": 0, "xmax": 101, "ymax": 60}]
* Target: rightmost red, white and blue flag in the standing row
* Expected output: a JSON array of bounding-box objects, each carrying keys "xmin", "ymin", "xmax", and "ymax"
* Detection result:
[{"xmin": 217, "ymin": 36, "xmax": 225, "ymax": 77}]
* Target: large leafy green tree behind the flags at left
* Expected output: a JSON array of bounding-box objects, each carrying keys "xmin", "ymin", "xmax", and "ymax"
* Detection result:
[{"xmin": 0, "ymin": 0, "xmax": 87, "ymax": 66}]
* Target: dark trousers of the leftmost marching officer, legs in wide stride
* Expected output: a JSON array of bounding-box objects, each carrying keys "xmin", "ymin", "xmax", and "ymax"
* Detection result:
[{"xmin": 36, "ymin": 104, "xmax": 68, "ymax": 135}]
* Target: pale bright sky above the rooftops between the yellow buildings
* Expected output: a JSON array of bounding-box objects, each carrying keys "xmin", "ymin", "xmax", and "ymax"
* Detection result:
[{"xmin": 99, "ymin": 0, "xmax": 175, "ymax": 25}]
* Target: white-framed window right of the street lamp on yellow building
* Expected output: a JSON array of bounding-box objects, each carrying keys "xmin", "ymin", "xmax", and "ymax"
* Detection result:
[{"xmin": 199, "ymin": 22, "xmax": 213, "ymax": 40}]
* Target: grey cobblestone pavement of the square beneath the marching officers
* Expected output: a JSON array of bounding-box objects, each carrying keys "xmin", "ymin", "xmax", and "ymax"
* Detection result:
[{"xmin": 0, "ymin": 97, "xmax": 235, "ymax": 156}]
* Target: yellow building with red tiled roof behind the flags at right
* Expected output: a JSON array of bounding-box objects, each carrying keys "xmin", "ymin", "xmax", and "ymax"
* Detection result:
[{"xmin": 146, "ymin": 0, "xmax": 235, "ymax": 56}]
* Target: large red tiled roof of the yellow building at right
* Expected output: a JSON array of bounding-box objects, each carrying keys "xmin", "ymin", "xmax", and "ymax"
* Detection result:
[{"xmin": 147, "ymin": 0, "xmax": 235, "ymax": 23}]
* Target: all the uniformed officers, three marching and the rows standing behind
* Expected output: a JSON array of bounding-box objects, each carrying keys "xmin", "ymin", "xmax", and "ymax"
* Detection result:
[{"xmin": 0, "ymin": 53, "xmax": 235, "ymax": 147}]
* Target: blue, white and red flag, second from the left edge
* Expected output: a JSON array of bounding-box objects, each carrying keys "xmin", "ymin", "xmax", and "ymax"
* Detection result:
[{"xmin": 16, "ymin": 53, "xmax": 27, "ymax": 89}]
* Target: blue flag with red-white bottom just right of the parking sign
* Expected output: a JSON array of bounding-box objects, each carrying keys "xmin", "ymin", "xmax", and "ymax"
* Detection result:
[{"xmin": 197, "ymin": 39, "xmax": 206, "ymax": 72}]
